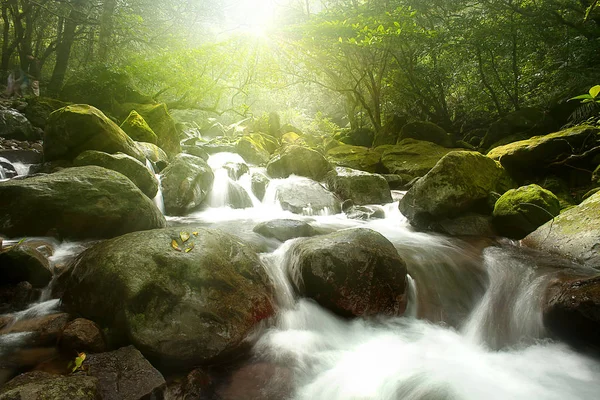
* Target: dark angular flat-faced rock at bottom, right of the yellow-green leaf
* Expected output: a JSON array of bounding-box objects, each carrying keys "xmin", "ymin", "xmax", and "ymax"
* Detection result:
[{"xmin": 83, "ymin": 346, "xmax": 166, "ymax": 400}]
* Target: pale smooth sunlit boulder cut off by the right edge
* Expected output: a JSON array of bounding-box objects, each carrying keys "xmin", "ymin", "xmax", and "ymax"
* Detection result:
[{"xmin": 523, "ymin": 189, "xmax": 600, "ymax": 268}]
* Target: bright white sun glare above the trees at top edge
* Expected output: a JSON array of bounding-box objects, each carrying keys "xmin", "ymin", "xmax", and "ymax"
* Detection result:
[{"xmin": 227, "ymin": 0, "xmax": 276, "ymax": 36}]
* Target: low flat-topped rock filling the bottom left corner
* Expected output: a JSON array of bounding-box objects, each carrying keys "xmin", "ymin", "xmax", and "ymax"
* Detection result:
[{"xmin": 0, "ymin": 371, "xmax": 101, "ymax": 400}]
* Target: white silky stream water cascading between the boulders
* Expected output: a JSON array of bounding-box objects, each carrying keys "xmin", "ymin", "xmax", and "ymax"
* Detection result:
[{"xmin": 0, "ymin": 155, "xmax": 600, "ymax": 400}]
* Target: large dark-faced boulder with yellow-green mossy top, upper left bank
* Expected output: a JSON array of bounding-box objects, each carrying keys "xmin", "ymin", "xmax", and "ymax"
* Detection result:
[{"xmin": 44, "ymin": 104, "xmax": 145, "ymax": 162}]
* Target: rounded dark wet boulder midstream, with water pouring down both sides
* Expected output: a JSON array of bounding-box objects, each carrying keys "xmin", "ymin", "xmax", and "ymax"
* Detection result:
[{"xmin": 288, "ymin": 228, "xmax": 406, "ymax": 317}]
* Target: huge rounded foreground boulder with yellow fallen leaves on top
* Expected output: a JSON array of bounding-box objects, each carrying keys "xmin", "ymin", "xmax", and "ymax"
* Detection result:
[{"xmin": 62, "ymin": 226, "xmax": 274, "ymax": 367}]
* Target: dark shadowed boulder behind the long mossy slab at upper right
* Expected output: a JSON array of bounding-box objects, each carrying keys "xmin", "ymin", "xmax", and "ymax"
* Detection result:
[{"xmin": 480, "ymin": 107, "xmax": 556, "ymax": 149}]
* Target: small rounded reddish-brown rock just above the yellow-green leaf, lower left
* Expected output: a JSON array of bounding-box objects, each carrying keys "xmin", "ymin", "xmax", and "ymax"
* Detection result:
[{"xmin": 58, "ymin": 318, "xmax": 106, "ymax": 354}]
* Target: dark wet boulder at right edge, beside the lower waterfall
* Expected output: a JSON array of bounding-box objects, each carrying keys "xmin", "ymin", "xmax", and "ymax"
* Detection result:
[{"xmin": 543, "ymin": 276, "xmax": 600, "ymax": 350}]
